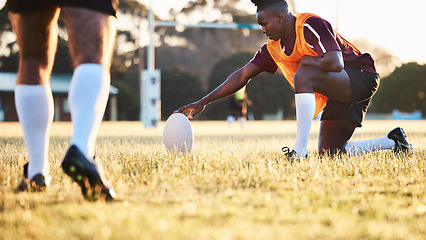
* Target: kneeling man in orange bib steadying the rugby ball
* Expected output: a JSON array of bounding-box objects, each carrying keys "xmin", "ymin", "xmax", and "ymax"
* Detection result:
[{"xmin": 177, "ymin": 0, "xmax": 412, "ymax": 161}]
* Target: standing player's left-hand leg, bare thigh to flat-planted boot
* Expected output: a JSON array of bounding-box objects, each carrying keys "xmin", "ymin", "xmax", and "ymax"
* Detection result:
[{"xmin": 9, "ymin": 6, "xmax": 60, "ymax": 191}]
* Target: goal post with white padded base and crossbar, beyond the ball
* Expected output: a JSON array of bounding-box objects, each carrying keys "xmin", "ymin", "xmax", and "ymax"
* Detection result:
[{"xmin": 140, "ymin": 8, "xmax": 262, "ymax": 128}]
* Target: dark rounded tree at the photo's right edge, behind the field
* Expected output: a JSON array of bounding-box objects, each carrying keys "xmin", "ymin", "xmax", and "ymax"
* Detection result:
[{"xmin": 371, "ymin": 62, "xmax": 426, "ymax": 113}]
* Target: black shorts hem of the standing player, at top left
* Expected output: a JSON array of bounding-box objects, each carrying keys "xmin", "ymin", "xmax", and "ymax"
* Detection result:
[{"xmin": 7, "ymin": 0, "xmax": 118, "ymax": 17}]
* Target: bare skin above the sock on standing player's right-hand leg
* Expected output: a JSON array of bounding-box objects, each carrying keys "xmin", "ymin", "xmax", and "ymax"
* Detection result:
[{"xmin": 62, "ymin": 7, "xmax": 117, "ymax": 69}]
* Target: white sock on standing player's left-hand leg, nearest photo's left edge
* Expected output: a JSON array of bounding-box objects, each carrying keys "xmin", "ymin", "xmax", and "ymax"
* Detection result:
[{"xmin": 15, "ymin": 84, "xmax": 54, "ymax": 179}]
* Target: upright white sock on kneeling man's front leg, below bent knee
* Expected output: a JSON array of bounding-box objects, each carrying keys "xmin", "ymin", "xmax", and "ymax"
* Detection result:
[{"xmin": 293, "ymin": 93, "xmax": 315, "ymax": 158}]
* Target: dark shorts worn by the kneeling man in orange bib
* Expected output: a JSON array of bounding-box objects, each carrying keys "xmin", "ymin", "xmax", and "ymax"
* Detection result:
[{"xmin": 321, "ymin": 67, "xmax": 380, "ymax": 127}]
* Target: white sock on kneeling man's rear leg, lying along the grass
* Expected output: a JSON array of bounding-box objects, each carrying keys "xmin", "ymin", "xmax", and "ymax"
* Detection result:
[{"xmin": 345, "ymin": 136, "xmax": 395, "ymax": 156}]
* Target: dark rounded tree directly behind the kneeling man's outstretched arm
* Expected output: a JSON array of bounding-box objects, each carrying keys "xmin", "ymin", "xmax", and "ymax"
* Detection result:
[{"xmin": 203, "ymin": 52, "xmax": 294, "ymax": 120}]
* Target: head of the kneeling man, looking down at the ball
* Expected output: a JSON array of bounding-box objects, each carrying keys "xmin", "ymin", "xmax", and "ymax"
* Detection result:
[{"xmin": 251, "ymin": 0, "xmax": 290, "ymax": 41}]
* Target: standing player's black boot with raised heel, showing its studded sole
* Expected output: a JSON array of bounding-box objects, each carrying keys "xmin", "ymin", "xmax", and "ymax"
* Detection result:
[{"xmin": 62, "ymin": 145, "xmax": 116, "ymax": 201}]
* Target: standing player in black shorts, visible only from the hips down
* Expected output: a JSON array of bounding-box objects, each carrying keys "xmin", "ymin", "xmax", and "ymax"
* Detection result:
[{"xmin": 7, "ymin": 0, "xmax": 118, "ymax": 201}]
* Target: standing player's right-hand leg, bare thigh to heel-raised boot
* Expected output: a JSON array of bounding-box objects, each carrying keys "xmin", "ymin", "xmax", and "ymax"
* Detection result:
[{"xmin": 62, "ymin": 7, "xmax": 117, "ymax": 200}]
